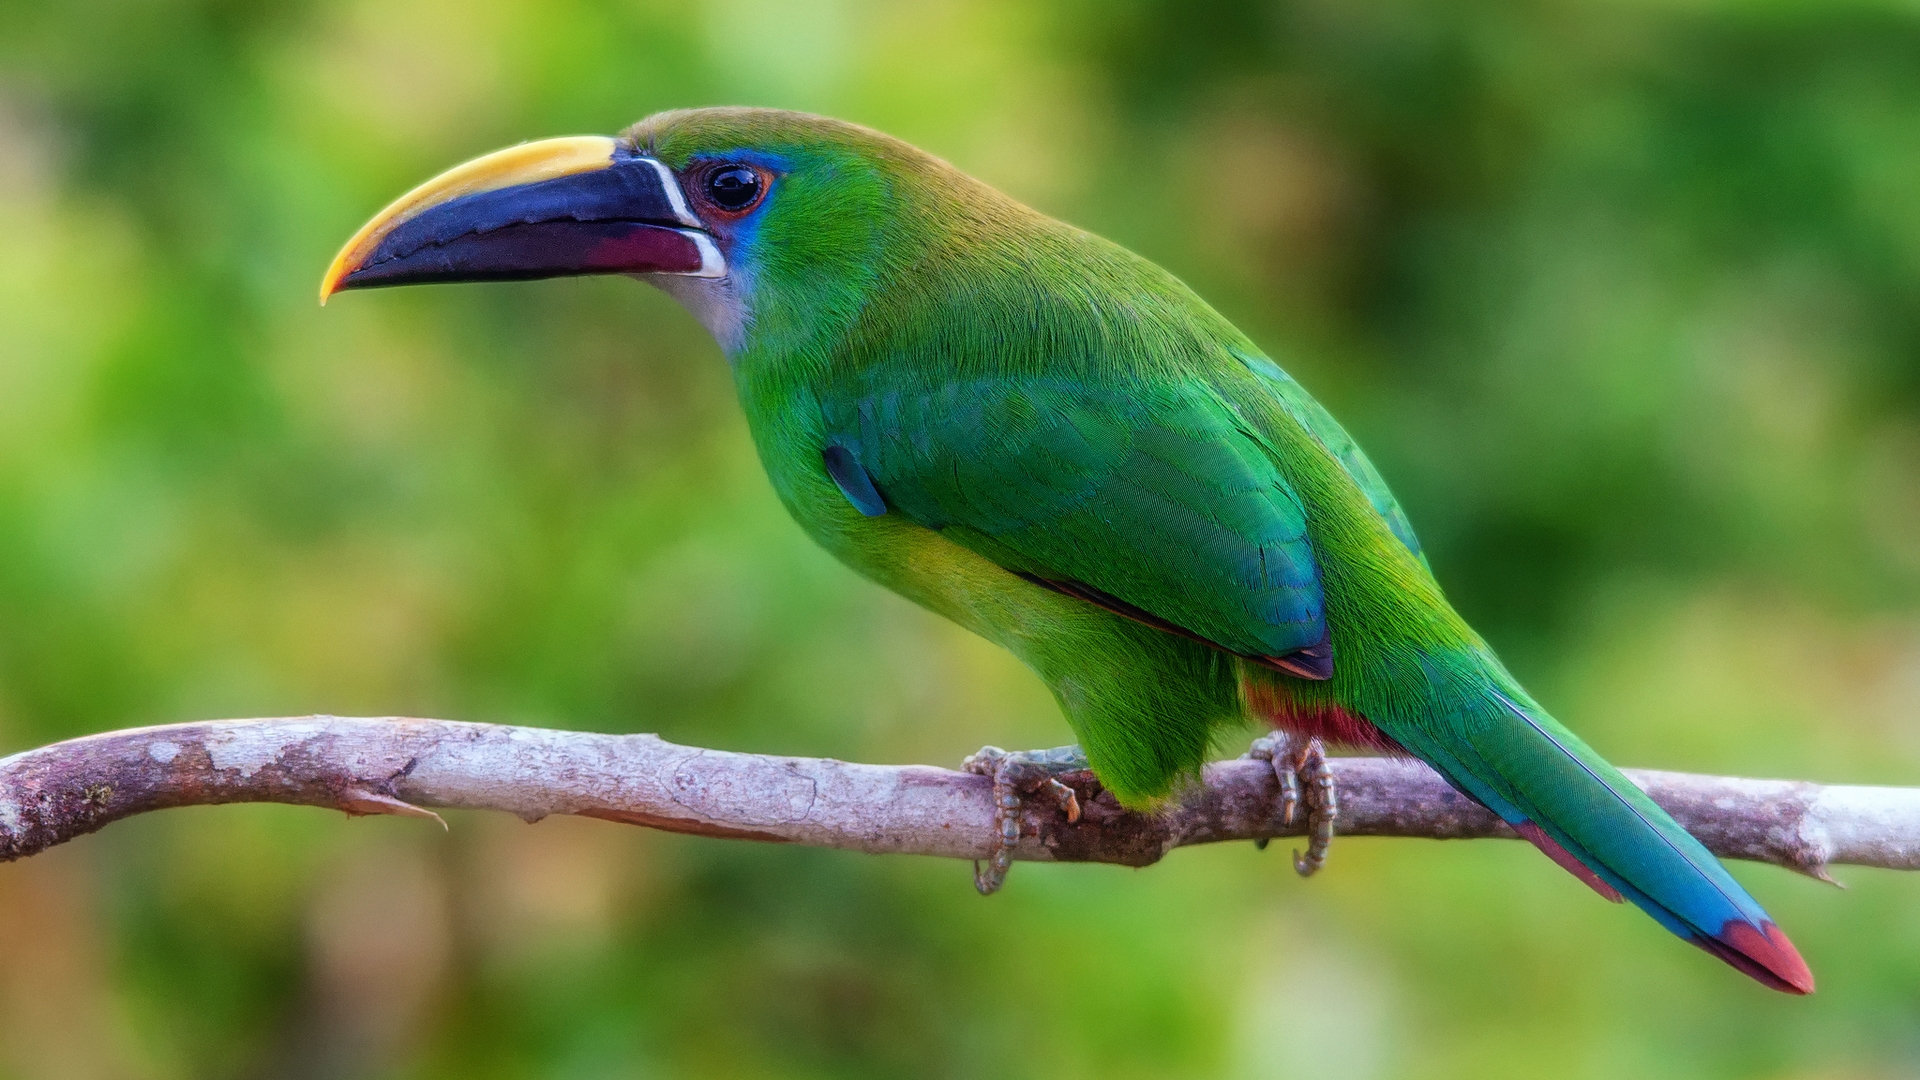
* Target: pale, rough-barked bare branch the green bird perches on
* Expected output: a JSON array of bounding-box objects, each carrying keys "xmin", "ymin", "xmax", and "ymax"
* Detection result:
[{"xmin": 0, "ymin": 717, "xmax": 1920, "ymax": 878}]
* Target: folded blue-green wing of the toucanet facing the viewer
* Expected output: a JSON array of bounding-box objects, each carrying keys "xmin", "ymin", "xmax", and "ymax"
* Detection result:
[{"xmin": 822, "ymin": 377, "xmax": 1332, "ymax": 678}]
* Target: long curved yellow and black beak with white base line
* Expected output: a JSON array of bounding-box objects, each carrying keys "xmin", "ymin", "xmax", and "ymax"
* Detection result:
[{"xmin": 321, "ymin": 136, "xmax": 726, "ymax": 304}]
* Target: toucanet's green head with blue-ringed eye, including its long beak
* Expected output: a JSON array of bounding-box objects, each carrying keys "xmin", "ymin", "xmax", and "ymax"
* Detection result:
[{"xmin": 321, "ymin": 108, "xmax": 975, "ymax": 356}]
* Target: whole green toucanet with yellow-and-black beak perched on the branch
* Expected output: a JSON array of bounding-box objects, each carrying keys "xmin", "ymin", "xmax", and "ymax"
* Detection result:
[{"xmin": 321, "ymin": 110, "xmax": 1812, "ymax": 994}]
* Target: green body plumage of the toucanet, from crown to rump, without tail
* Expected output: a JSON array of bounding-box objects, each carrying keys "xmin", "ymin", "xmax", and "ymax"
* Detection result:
[{"xmin": 630, "ymin": 111, "xmax": 1478, "ymax": 805}]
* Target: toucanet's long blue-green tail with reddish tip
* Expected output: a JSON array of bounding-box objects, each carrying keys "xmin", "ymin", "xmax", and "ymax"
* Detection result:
[{"xmin": 1394, "ymin": 661, "xmax": 1812, "ymax": 994}]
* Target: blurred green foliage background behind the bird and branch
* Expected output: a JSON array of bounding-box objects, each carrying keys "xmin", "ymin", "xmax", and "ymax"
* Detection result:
[{"xmin": 0, "ymin": 0, "xmax": 1920, "ymax": 1080}]
